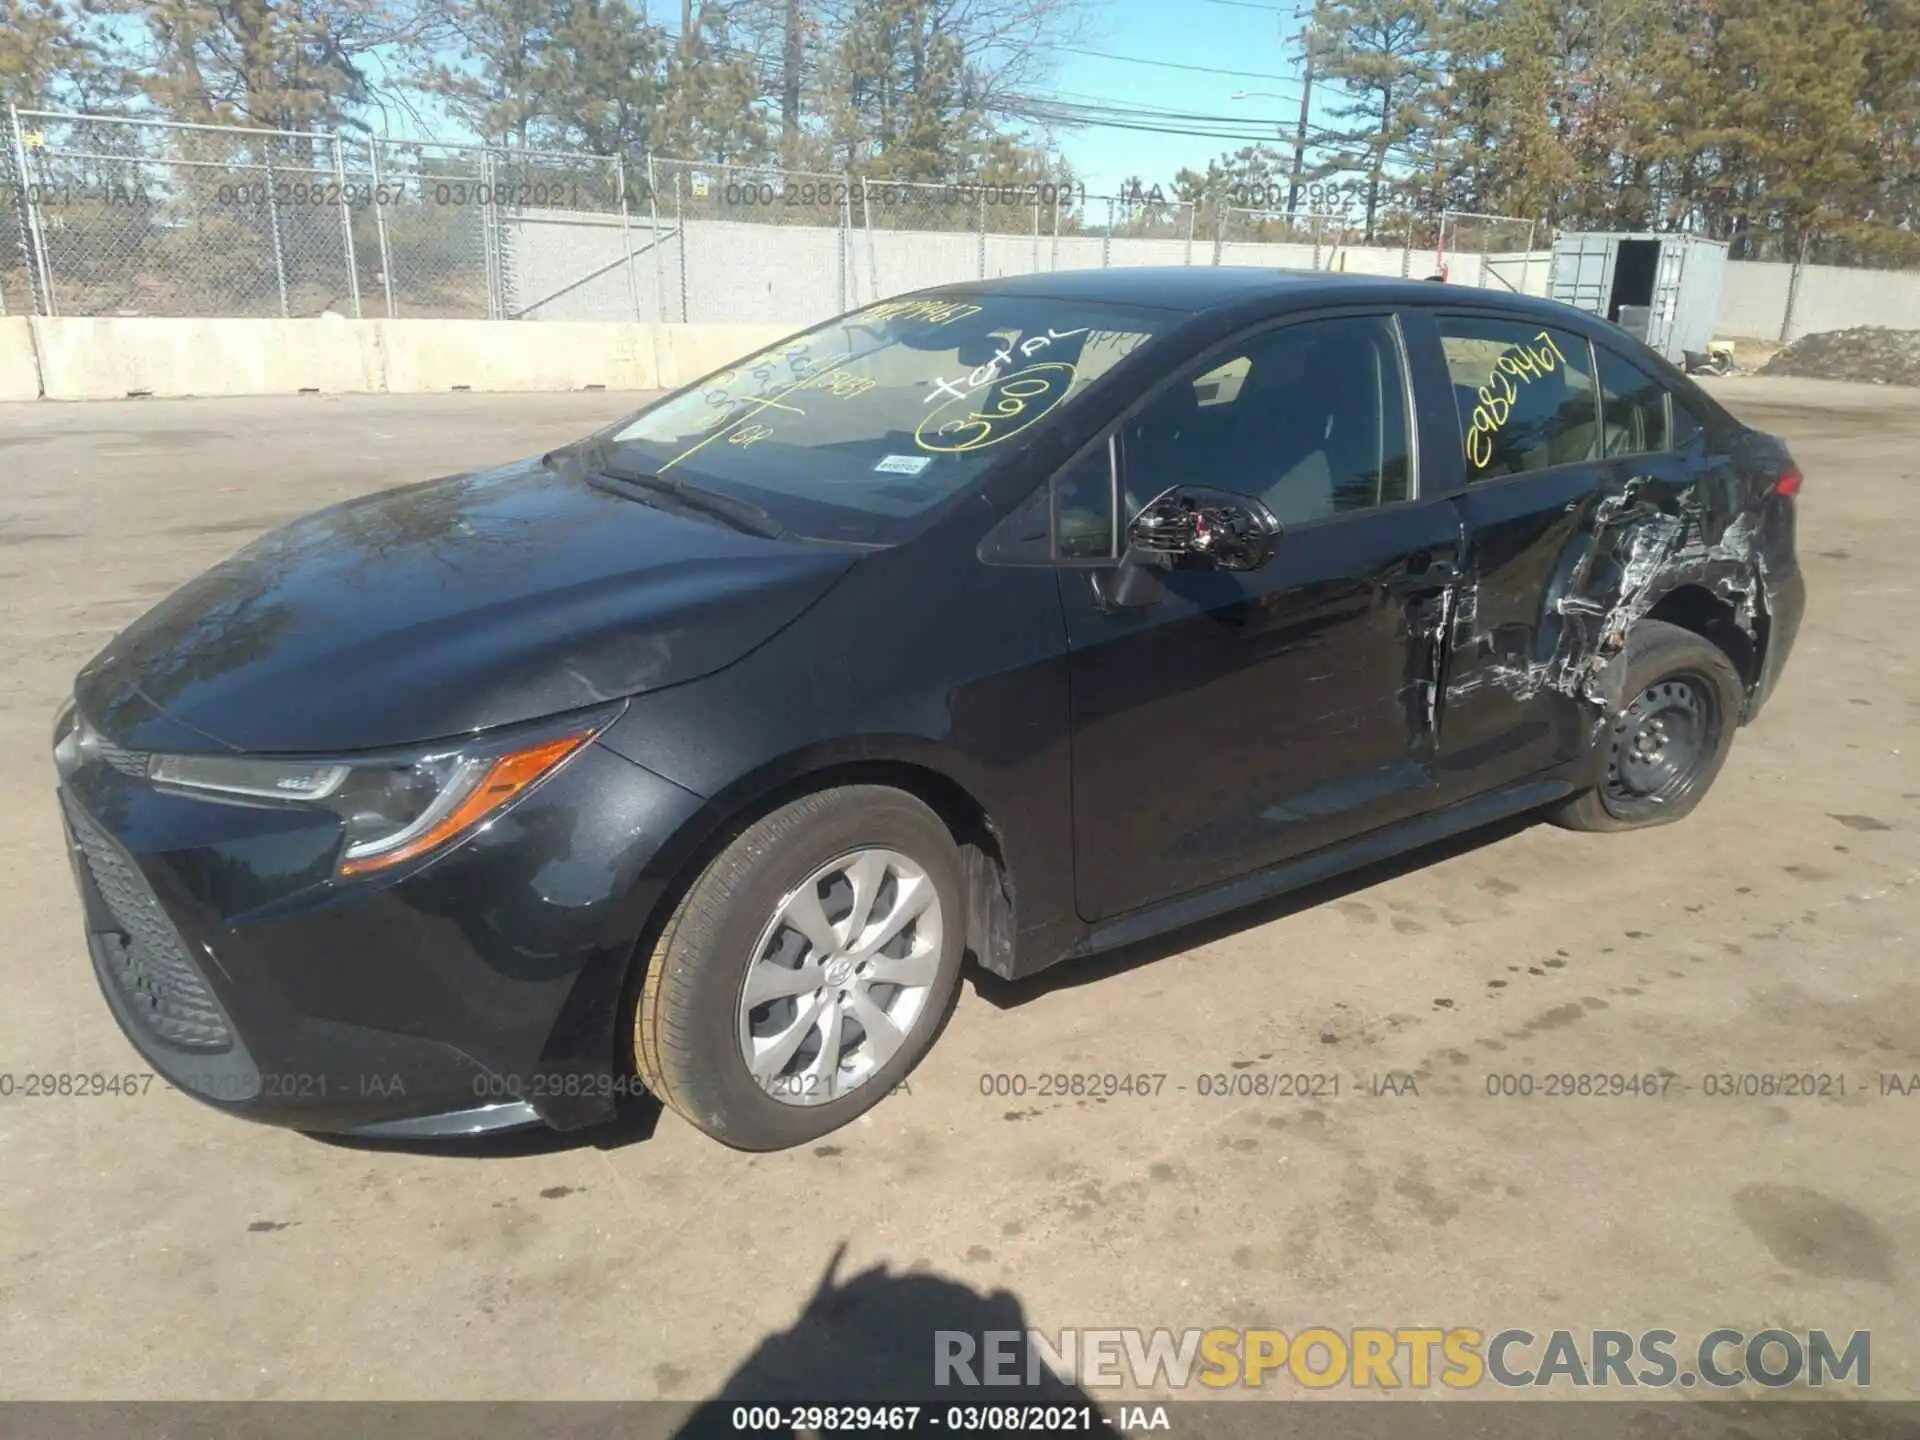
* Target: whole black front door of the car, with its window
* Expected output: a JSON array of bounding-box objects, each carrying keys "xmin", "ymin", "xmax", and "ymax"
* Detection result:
[{"xmin": 1056, "ymin": 313, "xmax": 1459, "ymax": 920}]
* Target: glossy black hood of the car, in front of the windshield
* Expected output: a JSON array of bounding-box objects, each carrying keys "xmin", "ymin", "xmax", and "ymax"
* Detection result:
[{"xmin": 75, "ymin": 461, "xmax": 854, "ymax": 753}]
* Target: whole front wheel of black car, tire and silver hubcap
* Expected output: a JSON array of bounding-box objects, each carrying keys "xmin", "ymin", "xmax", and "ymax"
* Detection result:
[{"xmin": 634, "ymin": 785, "xmax": 966, "ymax": 1150}]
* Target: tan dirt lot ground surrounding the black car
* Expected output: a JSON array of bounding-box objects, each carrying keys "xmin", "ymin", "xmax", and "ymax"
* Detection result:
[{"xmin": 0, "ymin": 378, "xmax": 1920, "ymax": 1400}]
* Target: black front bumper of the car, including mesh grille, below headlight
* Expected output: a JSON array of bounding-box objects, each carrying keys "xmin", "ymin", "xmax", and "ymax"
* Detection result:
[{"xmin": 60, "ymin": 745, "xmax": 699, "ymax": 1137}]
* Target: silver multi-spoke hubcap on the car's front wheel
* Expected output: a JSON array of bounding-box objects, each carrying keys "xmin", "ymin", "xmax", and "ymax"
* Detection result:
[{"xmin": 739, "ymin": 851, "xmax": 941, "ymax": 1106}]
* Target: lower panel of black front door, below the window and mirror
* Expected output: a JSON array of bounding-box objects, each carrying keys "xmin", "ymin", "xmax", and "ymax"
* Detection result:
[{"xmin": 1060, "ymin": 501, "xmax": 1459, "ymax": 920}]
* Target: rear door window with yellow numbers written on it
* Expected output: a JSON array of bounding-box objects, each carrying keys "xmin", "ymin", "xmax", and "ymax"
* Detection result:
[{"xmin": 1436, "ymin": 315, "xmax": 1601, "ymax": 480}]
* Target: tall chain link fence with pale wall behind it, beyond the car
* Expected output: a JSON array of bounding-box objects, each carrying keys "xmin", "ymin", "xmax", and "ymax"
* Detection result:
[{"xmin": 0, "ymin": 109, "xmax": 1548, "ymax": 326}]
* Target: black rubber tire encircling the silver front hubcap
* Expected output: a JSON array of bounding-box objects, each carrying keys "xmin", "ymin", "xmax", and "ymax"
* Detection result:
[{"xmin": 634, "ymin": 785, "xmax": 966, "ymax": 1150}]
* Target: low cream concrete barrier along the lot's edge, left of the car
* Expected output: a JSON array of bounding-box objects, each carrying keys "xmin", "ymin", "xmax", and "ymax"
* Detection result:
[{"xmin": 0, "ymin": 317, "xmax": 791, "ymax": 399}]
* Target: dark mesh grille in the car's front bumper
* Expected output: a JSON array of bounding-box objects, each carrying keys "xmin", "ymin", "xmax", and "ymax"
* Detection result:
[{"xmin": 67, "ymin": 803, "xmax": 232, "ymax": 1050}]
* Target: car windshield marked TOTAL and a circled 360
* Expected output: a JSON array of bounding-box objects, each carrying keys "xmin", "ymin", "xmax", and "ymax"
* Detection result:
[{"xmin": 605, "ymin": 294, "xmax": 1169, "ymax": 545}]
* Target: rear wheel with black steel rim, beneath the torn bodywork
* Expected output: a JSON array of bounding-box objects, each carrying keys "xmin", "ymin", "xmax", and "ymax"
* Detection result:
[{"xmin": 1548, "ymin": 620, "xmax": 1745, "ymax": 831}]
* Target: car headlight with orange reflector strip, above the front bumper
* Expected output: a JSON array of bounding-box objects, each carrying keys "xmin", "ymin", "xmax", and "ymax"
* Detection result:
[{"xmin": 148, "ymin": 710, "xmax": 618, "ymax": 876}]
